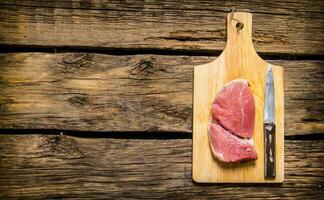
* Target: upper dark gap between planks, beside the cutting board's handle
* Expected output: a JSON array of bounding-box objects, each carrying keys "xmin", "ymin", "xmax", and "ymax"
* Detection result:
[{"xmin": 0, "ymin": 44, "xmax": 324, "ymax": 60}]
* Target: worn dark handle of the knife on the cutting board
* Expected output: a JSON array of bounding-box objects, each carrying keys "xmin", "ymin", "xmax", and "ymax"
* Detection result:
[{"xmin": 263, "ymin": 123, "xmax": 276, "ymax": 178}]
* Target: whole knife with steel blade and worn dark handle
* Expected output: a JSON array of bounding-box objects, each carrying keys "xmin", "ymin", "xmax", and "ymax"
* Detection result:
[{"xmin": 263, "ymin": 64, "xmax": 276, "ymax": 178}]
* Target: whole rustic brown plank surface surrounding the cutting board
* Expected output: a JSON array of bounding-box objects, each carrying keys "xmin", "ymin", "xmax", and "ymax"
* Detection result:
[{"xmin": 0, "ymin": 0, "xmax": 324, "ymax": 199}]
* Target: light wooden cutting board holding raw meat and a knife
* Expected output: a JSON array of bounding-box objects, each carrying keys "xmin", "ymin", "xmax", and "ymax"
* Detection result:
[{"xmin": 192, "ymin": 12, "xmax": 284, "ymax": 183}]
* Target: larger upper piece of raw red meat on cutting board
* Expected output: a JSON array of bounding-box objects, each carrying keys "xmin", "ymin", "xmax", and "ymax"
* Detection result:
[{"xmin": 212, "ymin": 79, "xmax": 255, "ymax": 138}]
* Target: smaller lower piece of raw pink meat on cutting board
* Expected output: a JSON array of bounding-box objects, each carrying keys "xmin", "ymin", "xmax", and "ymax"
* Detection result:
[{"xmin": 209, "ymin": 123, "xmax": 257, "ymax": 162}]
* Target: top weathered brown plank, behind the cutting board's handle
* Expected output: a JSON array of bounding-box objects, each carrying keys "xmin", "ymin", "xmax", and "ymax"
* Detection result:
[{"xmin": 0, "ymin": 0, "xmax": 324, "ymax": 54}]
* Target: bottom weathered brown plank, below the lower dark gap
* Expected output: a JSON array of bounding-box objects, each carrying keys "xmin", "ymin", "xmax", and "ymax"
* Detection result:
[{"xmin": 0, "ymin": 135, "xmax": 324, "ymax": 199}]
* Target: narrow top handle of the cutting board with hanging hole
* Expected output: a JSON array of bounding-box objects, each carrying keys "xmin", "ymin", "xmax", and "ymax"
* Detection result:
[{"xmin": 224, "ymin": 12, "xmax": 260, "ymax": 59}]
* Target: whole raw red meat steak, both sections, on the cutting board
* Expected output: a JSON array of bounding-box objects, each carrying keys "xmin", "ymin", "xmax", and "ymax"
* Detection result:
[{"xmin": 208, "ymin": 79, "xmax": 257, "ymax": 162}]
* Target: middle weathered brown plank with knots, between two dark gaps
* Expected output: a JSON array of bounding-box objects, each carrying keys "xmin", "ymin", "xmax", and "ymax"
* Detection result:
[{"xmin": 0, "ymin": 53, "xmax": 324, "ymax": 135}]
